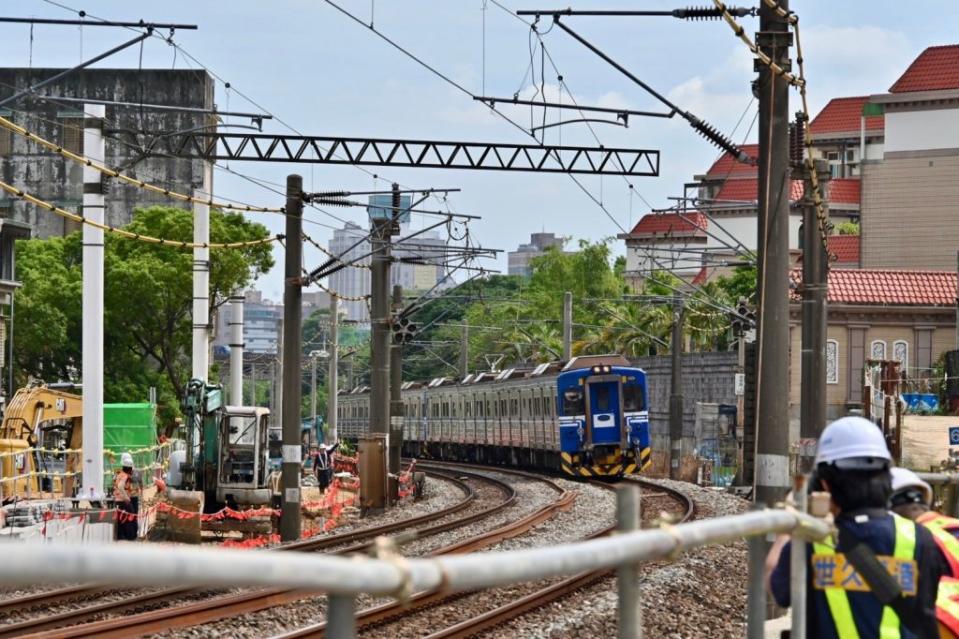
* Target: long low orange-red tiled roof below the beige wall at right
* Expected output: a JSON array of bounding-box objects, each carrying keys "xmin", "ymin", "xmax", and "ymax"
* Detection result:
[{"xmin": 790, "ymin": 268, "xmax": 956, "ymax": 307}]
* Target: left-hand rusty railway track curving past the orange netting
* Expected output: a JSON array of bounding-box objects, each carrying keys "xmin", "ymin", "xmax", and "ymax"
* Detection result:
[{"xmin": 0, "ymin": 464, "xmax": 575, "ymax": 638}]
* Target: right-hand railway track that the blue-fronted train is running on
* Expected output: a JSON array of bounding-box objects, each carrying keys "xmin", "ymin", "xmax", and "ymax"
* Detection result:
[{"xmin": 273, "ymin": 470, "xmax": 695, "ymax": 639}]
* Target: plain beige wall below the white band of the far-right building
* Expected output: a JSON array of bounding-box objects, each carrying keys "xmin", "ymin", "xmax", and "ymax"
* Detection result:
[{"xmin": 862, "ymin": 154, "xmax": 959, "ymax": 271}]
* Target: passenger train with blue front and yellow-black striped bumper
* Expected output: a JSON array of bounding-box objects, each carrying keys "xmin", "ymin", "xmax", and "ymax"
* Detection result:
[{"xmin": 337, "ymin": 355, "xmax": 651, "ymax": 477}]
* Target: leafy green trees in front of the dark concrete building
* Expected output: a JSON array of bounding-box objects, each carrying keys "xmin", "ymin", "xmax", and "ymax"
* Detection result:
[{"xmin": 14, "ymin": 206, "xmax": 273, "ymax": 428}]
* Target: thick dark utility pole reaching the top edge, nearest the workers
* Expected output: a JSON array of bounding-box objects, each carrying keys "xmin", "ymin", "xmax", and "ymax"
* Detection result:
[{"xmin": 754, "ymin": 0, "xmax": 792, "ymax": 504}]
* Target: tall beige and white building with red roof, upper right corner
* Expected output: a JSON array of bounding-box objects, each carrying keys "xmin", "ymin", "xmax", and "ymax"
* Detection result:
[{"xmin": 862, "ymin": 45, "xmax": 959, "ymax": 270}]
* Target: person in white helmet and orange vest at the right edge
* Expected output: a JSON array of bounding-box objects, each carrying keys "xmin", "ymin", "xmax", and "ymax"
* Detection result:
[{"xmin": 889, "ymin": 468, "xmax": 959, "ymax": 639}]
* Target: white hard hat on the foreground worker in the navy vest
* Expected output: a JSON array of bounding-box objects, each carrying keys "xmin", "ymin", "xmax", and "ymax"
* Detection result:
[{"xmin": 816, "ymin": 417, "xmax": 892, "ymax": 470}]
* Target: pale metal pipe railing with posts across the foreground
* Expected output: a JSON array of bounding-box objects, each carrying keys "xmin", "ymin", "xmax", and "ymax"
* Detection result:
[{"xmin": 0, "ymin": 486, "xmax": 831, "ymax": 639}]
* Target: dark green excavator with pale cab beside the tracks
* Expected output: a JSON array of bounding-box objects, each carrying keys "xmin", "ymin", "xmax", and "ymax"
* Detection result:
[{"xmin": 171, "ymin": 379, "xmax": 274, "ymax": 512}]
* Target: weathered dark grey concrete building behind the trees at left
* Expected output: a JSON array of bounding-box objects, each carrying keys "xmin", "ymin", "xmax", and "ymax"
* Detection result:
[{"xmin": 0, "ymin": 68, "xmax": 214, "ymax": 237}]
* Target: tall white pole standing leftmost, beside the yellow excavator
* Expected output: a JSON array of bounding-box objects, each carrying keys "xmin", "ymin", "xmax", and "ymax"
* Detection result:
[{"xmin": 82, "ymin": 104, "xmax": 106, "ymax": 497}]
